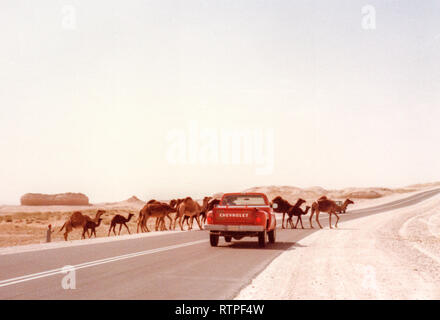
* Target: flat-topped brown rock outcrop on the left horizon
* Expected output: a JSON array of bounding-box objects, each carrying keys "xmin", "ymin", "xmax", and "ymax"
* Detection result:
[{"xmin": 20, "ymin": 192, "xmax": 89, "ymax": 206}]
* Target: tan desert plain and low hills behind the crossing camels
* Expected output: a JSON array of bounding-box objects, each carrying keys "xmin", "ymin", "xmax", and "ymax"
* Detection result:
[{"xmin": 0, "ymin": 182, "xmax": 440, "ymax": 247}]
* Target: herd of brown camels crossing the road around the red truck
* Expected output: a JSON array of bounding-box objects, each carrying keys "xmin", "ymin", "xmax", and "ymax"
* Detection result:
[{"xmin": 59, "ymin": 196, "xmax": 354, "ymax": 241}]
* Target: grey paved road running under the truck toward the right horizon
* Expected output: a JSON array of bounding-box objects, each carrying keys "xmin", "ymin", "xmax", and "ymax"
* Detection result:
[{"xmin": 0, "ymin": 189, "xmax": 440, "ymax": 300}]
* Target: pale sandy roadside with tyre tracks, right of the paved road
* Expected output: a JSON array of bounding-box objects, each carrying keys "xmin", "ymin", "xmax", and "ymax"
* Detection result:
[{"xmin": 236, "ymin": 191, "xmax": 440, "ymax": 300}]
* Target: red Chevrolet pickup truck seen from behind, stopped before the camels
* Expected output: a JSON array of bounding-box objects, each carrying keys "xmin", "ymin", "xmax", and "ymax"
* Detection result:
[{"xmin": 205, "ymin": 193, "xmax": 276, "ymax": 247}]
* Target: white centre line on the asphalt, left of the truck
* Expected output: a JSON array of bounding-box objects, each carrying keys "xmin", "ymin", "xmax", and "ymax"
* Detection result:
[{"xmin": 0, "ymin": 240, "xmax": 208, "ymax": 288}]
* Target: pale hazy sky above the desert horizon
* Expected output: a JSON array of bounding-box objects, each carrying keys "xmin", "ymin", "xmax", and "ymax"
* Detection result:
[{"xmin": 0, "ymin": 0, "xmax": 440, "ymax": 203}]
